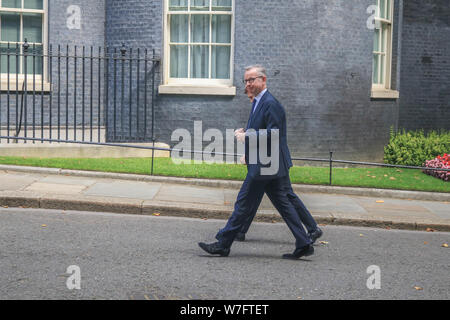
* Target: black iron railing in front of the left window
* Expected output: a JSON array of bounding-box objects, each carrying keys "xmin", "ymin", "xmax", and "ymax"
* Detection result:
[{"xmin": 0, "ymin": 41, "xmax": 160, "ymax": 143}]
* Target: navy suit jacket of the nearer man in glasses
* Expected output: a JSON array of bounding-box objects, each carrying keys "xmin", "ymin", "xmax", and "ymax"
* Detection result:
[{"xmin": 245, "ymin": 91, "xmax": 292, "ymax": 180}]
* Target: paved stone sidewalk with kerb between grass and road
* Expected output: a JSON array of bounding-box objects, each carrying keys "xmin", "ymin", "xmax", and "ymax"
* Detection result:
[{"xmin": 0, "ymin": 165, "xmax": 450, "ymax": 231}]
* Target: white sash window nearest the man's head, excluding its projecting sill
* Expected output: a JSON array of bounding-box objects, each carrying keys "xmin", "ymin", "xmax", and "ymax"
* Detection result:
[{"xmin": 164, "ymin": 0, "xmax": 234, "ymax": 95}]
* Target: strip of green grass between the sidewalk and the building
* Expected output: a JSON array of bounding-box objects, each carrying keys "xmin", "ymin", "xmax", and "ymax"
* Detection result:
[{"xmin": 0, "ymin": 156, "xmax": 450, "ymax": 192}]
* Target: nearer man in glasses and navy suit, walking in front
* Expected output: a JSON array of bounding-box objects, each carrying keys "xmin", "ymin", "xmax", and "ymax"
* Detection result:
[{"xmin": 199, "ymin": 66, "xmax": 314, "ymax": 259}]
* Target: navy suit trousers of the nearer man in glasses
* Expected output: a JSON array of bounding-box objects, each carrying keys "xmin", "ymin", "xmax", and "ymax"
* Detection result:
[{"xmin": 216, "ymin": 174, "xmax": 311, "ymax": 248}]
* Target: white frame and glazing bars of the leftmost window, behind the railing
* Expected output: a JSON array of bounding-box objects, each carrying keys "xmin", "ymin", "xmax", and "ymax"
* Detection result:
[{"xmin": 0, "ymin": 0, "xmax": 50, "ymax": 91}]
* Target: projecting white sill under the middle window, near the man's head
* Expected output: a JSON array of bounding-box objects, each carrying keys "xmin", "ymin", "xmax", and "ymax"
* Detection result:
[{"xmin": 158, "ymin": 84, "xmax": 236, "ymax": 96}]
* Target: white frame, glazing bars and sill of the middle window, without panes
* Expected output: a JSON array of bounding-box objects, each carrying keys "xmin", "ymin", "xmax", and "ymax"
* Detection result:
[{"xmin": 159, "ymin": 0, "xmax": 235, "ymax": 95}]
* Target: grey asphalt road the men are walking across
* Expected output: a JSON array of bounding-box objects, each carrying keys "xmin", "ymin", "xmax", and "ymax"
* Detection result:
[{"xmin": 0, "ymin": 208, "xmax": 450, "ymax": 300}]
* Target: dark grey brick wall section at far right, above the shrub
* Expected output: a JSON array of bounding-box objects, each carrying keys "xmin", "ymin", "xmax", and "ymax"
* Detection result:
[{"xmin": 399, "ymin": 0, "xmax": 450, "ymax": 130}]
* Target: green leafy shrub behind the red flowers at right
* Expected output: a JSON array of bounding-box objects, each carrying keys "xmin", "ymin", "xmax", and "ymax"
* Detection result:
[{"xmin": 384, "ymin": 128, "xmax": 450, "ymax": 166}]
